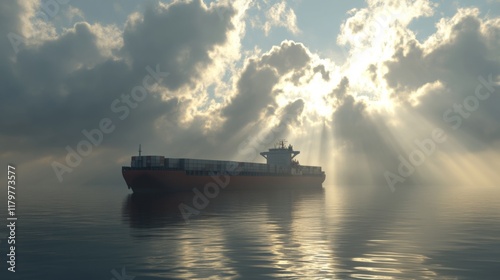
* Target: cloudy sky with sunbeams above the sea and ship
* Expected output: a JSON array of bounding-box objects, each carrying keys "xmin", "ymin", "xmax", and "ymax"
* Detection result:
[{"xmin": 0, "ymin": 0, "xmax": 500, "ymax": 191}]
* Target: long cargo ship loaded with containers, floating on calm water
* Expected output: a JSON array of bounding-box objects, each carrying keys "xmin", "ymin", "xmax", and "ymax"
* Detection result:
[{"xmin": 122, "ymin": 140, "xmax": 325, "ymax": 193}]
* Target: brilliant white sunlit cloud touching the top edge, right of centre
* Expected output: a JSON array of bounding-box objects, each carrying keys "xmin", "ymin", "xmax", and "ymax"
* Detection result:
[{"xmin": 337, "ymin": 0, "xmax": 434, "ymax": 102}]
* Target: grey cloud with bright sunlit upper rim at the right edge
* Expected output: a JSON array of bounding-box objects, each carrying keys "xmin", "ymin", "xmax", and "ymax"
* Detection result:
[{"xmin": 385, "ymin": 9, "xmax": 499, "ymax": 90}]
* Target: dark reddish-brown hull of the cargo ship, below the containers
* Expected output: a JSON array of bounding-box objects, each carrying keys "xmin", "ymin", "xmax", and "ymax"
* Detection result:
[{"xmin": 122, "ymin": 169, "xmax": 325, "ymax": 192}]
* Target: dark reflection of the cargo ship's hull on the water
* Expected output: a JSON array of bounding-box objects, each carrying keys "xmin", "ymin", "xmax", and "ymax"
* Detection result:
[{"xmin": 122, "ymin": 189, "xmax": 324, "ymax": 228}]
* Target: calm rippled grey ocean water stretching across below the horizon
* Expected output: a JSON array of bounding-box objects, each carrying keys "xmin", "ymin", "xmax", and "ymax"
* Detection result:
[{"xmin": 0, "ymin": 185, "xmax": 500, "ymax": 280}]
